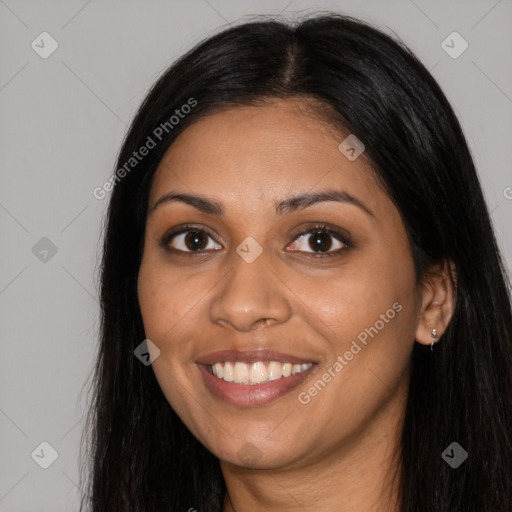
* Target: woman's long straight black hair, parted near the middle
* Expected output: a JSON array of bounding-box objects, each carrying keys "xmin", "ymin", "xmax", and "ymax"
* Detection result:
[{"xmin": 78, "ymin": 13, "xmax": 512, "ymax": 512}]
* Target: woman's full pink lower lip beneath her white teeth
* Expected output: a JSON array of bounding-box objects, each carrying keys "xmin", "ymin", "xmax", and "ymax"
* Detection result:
[{"xmin": 198, "ymin": 364, "xmax": 316, "ymax": 407}]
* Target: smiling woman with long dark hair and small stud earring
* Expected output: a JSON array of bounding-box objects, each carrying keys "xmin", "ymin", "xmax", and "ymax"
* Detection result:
[{"xmin": 79, "ymin": 14, "xmax": 512, "ymax": 512}]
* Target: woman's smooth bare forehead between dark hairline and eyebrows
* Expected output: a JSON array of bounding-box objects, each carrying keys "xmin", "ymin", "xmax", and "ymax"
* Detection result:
[{"xmin": 150, "ymin": 99, "xmax": 386, "ymax": 216}]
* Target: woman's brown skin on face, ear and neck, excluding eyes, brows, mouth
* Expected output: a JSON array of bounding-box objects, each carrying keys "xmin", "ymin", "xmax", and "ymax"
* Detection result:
[{"xmin": 138, "ymin": 99, "xmax": 454, "ymax": 512}]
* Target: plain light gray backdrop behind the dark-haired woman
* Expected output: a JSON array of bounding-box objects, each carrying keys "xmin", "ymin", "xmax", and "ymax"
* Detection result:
[{"xmin": 0, "ymin": 0, "xmax": 512, "ymax": 512}]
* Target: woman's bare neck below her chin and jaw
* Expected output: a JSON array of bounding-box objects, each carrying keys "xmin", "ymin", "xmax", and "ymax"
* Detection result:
[{"xmin": 221, "ymin": 376, "xmax": 406, "ymax": 512}]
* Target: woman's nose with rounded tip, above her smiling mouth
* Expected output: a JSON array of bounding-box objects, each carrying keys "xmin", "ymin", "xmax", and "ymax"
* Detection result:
[{"xmin": 210, "ymin": 253, "xmax": 291, "ymax": 332}]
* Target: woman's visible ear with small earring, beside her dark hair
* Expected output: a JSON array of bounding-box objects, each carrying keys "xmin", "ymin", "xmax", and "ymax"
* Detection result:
[{"xmin": 416, "ymin": 260, "xmax": 457, "ymax": 345}]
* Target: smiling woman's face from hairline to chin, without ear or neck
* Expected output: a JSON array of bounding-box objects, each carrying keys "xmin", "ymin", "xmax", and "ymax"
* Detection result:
[{"xmin": 138, "ymin": 100, "xmax": 420, "ymax": 468}]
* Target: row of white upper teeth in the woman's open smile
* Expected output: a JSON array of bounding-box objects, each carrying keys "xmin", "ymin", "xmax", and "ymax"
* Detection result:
[{"xmin": 211, "ymin": 361, "xmax": 313, "ymax": 384}]
